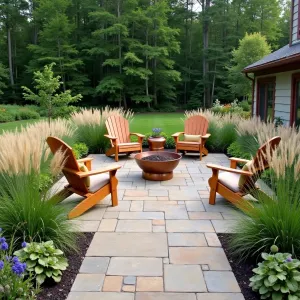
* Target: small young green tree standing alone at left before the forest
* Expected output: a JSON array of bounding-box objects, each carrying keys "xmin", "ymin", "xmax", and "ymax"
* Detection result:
[{"xmin": 22, "ymin": 63, "xmax": 82, "ymax": 120}]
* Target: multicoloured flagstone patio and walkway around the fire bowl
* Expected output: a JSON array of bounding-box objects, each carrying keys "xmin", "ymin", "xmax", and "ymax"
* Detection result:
[{"xmin": 62, "ymin": 154, "xmax": 244, "ymax": 300}]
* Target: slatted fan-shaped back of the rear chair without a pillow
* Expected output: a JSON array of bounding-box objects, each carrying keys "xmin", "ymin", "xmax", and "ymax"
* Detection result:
[{"xmin": 105, "ymin": 116, "xmax": 130, "ymax": 143}]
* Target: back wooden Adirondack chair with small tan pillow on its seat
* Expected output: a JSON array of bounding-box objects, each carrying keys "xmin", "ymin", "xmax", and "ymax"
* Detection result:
[{"xmin": 172, "ymin": 116, "xmax": 210, "ymax": 160}]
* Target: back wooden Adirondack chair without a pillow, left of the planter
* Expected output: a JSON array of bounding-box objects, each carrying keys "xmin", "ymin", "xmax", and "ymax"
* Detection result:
[{"xmin": 104, "ymin": 116, "xmax": 144, "ymax": 161}]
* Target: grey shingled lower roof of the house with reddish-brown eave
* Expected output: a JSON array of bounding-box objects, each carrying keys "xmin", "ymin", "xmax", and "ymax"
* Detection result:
[{"xmin": 243, "ymin": 43, "xmax": 300, "ymax": 73}]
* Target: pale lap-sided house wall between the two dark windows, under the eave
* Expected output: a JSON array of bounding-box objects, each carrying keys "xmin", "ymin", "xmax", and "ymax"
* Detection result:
[{"xmin": 253, "ymin": 71, "xmax": 298, "ymax": 124}]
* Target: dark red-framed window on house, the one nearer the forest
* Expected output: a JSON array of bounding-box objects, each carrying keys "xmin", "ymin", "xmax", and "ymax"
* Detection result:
[{"xmin": 256, "ymin": 77, "xmax": 276, "ymax": 121}]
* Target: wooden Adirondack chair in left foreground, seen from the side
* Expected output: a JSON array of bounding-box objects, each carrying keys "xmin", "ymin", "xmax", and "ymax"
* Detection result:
[{"xmin": 47, "ymin": 137, "xmax": 121, "ymax": 219}]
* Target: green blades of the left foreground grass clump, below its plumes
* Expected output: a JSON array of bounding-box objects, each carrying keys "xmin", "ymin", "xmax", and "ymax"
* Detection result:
[{"xmin": 0, "ymin": 171, "xmax": 76, "ymax": 251}]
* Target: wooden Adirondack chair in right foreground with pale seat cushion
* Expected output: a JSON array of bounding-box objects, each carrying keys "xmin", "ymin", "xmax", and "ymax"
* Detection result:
[{"xmin": 206, "ymin": 136, "xmax": 281, "ymax": 209}]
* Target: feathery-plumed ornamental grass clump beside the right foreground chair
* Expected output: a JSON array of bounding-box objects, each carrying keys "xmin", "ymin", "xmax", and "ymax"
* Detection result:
[{"xmin": 230, "ymin": 129, "xmax": 300, "ymax": 259}]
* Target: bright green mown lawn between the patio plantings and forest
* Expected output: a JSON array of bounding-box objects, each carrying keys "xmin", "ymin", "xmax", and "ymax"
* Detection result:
[{"xmin": 0, "ymin": 113, "xmax": 183, "ymax": 134}]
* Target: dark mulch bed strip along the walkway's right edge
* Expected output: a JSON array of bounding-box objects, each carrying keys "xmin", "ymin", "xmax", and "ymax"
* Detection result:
[{"xmin": 218, "ymin": 233, "xmax": 260, "ymax": 300}]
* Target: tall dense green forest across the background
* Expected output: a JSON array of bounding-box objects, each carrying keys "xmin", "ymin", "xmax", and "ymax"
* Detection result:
[{"xmin": 0, "ymin": 0, "xmax": 290, "ymax": 108}]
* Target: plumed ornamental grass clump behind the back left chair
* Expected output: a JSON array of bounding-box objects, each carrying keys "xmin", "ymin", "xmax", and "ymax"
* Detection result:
[{"xmin": 71, "ymin": 106, "xmax": 133, "ymax": 153}]
